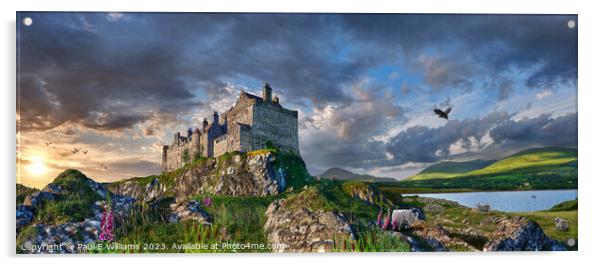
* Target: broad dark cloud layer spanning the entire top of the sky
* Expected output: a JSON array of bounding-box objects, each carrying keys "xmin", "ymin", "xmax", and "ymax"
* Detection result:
[{"xmin": 17, "ymin": 13, "xmax": 577, "ymax": 134}]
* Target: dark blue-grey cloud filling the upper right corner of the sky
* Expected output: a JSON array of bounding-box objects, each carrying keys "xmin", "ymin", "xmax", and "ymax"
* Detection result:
[{"xmin": 342, "ymin": 15, "xmax": 577, "ymax": 91}]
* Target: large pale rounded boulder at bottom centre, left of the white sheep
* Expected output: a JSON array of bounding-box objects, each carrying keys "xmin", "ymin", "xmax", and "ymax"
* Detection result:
[{"xmin": 264, "ymin": 199, "xmax": 355, "ymax": 252}]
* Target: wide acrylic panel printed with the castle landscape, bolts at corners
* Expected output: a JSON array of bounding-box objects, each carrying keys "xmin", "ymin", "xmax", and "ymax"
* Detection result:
[{"xmin": 16, "ymin": 12, "xmax": 578, "ymax": 254}]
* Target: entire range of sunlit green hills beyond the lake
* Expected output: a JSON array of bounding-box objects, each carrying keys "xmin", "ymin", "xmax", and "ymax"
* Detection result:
[{"xmin": 407, "ymin": 147, "xmax": 577, "ymax": 180}]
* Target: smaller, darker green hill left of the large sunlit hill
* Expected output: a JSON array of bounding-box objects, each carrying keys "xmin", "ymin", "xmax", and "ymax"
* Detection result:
[{"xmin": 408, "ymin": 160, "xmax": 496, "ymax": 180}]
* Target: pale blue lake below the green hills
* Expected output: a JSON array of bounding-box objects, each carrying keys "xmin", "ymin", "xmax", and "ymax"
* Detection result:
[{"xmin": 403, "ymin": 189, "xmax": 577, "ymax": 212}]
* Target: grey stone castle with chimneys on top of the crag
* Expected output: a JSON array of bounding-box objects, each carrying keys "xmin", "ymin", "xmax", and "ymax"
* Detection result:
[{"xmin": 161, "ymin": 83, "xmax": 299, "ymax": 171}]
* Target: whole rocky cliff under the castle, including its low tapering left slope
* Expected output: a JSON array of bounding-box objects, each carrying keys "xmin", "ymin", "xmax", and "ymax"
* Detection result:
[{"xmin": 107, "ymin": 150, "xmax": 294, "ymax": 201}]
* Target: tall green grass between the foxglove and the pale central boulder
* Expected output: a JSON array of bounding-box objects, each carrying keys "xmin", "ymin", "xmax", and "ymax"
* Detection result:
[{"xmin": 105, "ymin": 195, "xmax": 275, "ymax": 253}]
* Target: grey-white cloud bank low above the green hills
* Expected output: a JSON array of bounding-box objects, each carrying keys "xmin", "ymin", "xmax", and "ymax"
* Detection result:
[{"xmin": 386, "ymin": 112, "xmax": 577, "ymax": 165}]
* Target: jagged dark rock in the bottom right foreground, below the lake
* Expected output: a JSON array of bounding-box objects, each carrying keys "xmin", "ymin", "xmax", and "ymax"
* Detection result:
[{"xmin": 483, "ymin": 217, "xmax": 566, "ymax": 251}]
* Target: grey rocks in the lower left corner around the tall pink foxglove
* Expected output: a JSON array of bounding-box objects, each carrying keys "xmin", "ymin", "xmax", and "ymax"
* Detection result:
[{"xmin": 16, "ymin": 170, "xmax": 135, "ymax": 253}]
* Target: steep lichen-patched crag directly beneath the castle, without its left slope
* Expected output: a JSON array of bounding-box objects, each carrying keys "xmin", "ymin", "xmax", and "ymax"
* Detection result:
[{"xmin": 174, "ymin": 152, "xmax": 286, "ymax": 199}]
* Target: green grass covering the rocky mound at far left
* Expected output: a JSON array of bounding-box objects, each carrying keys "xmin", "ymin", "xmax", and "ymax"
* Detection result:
[{"xmin": 34, "ymin": 169, "xmax": 102, "ymax": 224}]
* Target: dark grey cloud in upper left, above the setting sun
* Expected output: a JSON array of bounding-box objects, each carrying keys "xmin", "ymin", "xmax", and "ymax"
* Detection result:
[{"xmin": 18, "ymin": 13, "xmax": 193, "ymax": 130}]
